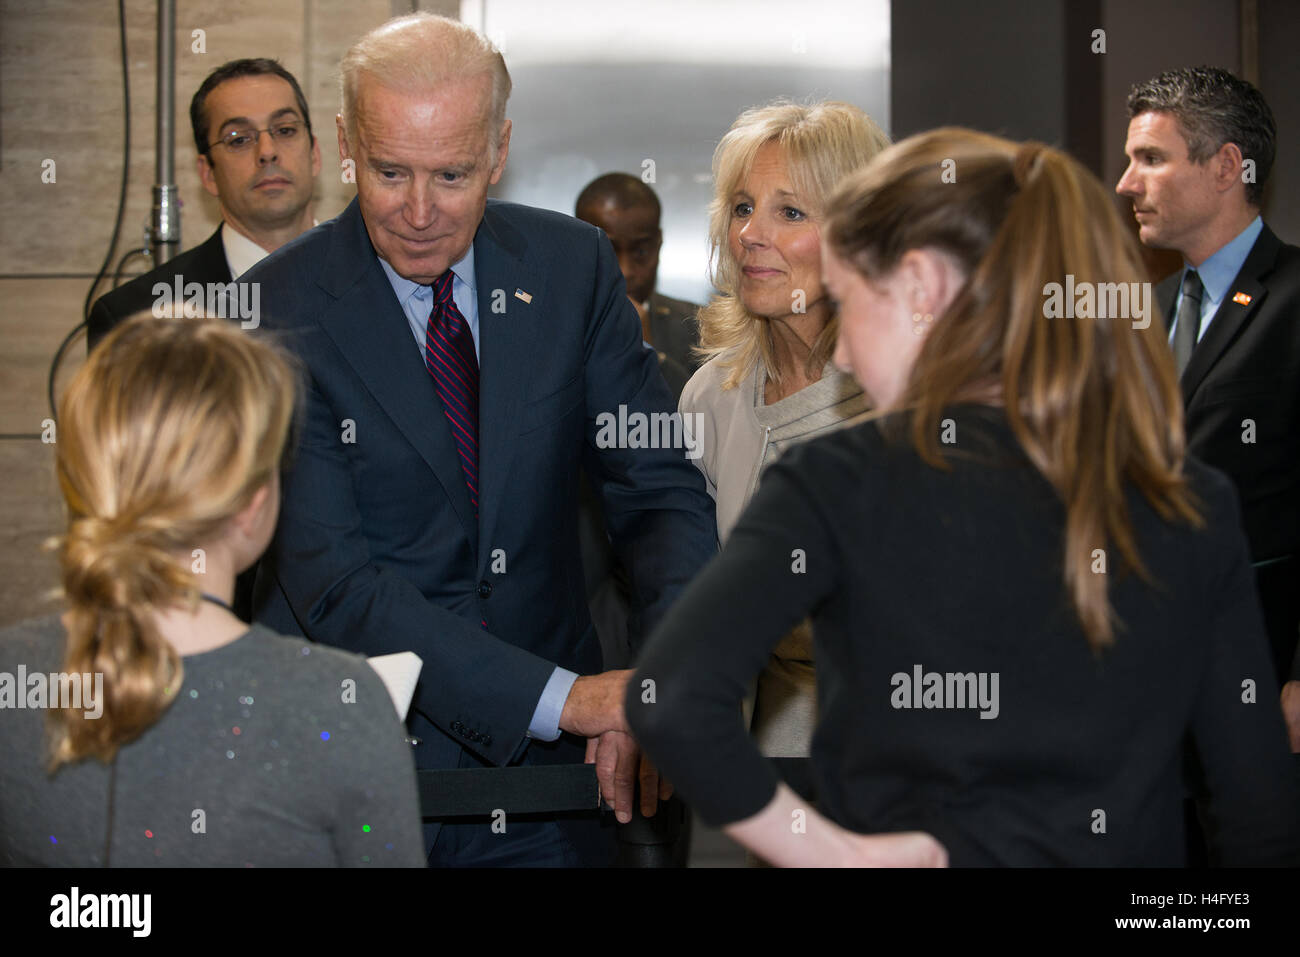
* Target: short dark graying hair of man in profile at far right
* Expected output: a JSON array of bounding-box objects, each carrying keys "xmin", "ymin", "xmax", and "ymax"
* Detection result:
[{"xmin": 1128, "ymin": 66, "xmax": 1278, "ymax": 207}]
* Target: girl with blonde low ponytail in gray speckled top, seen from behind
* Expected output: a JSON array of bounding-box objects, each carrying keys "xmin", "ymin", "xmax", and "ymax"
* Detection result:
[{"xmin": 0, "ymin": 319, "xmax": 423, "ymax": 866}]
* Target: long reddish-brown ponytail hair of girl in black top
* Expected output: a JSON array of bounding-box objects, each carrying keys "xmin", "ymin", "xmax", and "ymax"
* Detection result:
[{"xmin": 826, "ymin": 127, "xmax": 1201, "ymax": 650}]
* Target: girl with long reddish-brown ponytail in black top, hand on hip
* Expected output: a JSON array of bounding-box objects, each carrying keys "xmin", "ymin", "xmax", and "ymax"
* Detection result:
[{"xmin": 627, "ymin": 129, "xmax": 1300, "ymax": 866}]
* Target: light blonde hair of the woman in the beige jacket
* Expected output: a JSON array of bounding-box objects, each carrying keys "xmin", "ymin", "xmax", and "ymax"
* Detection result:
[{"xmin": 697, "ymin": 100, "xmax": 889, "ymax": 389}]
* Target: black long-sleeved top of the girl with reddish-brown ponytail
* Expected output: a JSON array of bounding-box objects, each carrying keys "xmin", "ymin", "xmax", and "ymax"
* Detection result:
[{"xmin": 627, "ymin": 406, "xmax": 1300, "ymax": 867}]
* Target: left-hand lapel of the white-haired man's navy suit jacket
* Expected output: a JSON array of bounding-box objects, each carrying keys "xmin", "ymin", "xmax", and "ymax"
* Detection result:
[{"xmin": 319, "ymin": 199, "xmax": 478, "ymax": 553}]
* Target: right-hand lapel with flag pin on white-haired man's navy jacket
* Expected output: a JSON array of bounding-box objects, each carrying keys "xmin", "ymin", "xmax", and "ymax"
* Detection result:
[{"xmin": 470, "ymin": 202, "xmax": 546, "ymax": 553}]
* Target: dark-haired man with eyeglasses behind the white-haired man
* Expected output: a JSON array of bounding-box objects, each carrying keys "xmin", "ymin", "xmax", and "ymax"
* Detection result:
[{"xmin": 86, "ymin": 57, "xmax": 321, "ymax": 348}]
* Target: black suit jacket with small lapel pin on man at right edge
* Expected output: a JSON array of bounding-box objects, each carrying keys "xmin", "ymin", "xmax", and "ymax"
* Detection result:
[{"xmin": 1156, "ymin": 226, "xmax": 1300, "ymax": 680}]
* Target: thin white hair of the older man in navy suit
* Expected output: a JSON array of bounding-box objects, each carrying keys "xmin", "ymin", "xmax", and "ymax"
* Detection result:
[{"xmin": 339, "ymin": 13, "xmax": 511, "ymax": 149}]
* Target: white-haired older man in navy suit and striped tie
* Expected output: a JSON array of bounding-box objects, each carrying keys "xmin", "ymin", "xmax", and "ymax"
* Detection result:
[{"xmin": 246, "ymin": 14, "xmax": 716, "ymax": 865}]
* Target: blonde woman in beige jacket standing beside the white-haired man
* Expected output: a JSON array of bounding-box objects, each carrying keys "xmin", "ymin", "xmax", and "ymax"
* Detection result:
[{"xmin": 680, "ymin": 101, "xmax": 889, "ymax": 757}]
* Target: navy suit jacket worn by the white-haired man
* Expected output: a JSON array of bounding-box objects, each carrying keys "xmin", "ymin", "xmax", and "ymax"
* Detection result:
[{"xmin": 244, "ymin": 200, "xmax": 716, "ymax": 862}]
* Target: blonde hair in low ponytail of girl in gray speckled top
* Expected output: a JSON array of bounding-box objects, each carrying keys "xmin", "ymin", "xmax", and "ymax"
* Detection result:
[{"xmin": 51, "ymin": 317, "xmax": 295, "ymax": 768}]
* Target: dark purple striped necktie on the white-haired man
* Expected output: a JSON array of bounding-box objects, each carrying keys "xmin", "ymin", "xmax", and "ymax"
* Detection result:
[{"xmin": 424, "ymin": 269, "xmax": 478, "ymax": 512}]
